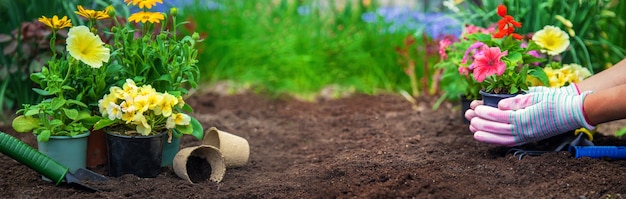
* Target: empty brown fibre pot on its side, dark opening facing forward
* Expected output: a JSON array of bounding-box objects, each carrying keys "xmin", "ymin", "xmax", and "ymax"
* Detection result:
[{"xmin": 173, "ymin": 145, "xmax": 226, "ymax": 184}]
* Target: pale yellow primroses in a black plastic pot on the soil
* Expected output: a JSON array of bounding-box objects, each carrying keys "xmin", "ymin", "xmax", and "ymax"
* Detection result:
[{"xmin": 94, "ymin": 79, "xmax": 202, "ymax": 177}]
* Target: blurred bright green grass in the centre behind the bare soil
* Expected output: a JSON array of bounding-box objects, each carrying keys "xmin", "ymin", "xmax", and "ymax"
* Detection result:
[{"xmin": 184, "ymin": 0, "xmax": 421, "ymax": 99}]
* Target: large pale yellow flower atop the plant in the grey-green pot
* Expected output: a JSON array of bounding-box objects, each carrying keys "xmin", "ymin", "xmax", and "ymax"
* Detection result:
[{"xmin": 67, "ymin": 26, "xmax": 111, "ymax": 68}]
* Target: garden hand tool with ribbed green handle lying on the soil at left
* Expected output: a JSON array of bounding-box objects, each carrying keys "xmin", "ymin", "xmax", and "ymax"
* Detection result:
[{"xmin": 0, "ymin": 132, "xmax": 108, "ymax": 192}]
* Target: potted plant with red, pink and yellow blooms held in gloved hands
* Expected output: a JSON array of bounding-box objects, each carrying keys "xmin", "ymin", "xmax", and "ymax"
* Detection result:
[{"xmin": 442, "ymin": 5, "xmax": 584, "ymax": 106}]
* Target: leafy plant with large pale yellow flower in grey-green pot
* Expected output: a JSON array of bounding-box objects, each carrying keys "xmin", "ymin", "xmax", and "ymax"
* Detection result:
[{"xmin": 12, "ymin": 16, "xmax": 110, "ymax": 179}]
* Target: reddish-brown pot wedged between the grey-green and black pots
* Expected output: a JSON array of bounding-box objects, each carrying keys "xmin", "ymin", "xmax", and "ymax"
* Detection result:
[{"xmin": 87, "ymin": 129, "xmax": 108, "ymax": 169}]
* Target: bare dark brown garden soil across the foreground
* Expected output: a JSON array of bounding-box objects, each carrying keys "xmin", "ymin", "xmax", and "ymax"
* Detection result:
[{"xmin": 0, "ymin": 92, "xmax": 626, "ymax": 198}]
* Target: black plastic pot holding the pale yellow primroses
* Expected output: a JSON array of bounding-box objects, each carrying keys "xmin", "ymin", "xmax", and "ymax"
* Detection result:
[{"xmin": 107, "ymin": 132, "xmax": 167, "ymax": 178}]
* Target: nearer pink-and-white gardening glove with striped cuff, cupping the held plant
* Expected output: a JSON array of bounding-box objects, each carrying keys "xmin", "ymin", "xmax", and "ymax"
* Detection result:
[{"xmin": 466, "ymin": 92, "xmax": 595, "ymax": 146}]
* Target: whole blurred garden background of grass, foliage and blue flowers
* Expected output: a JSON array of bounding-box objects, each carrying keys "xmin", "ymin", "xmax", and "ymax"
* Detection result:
[{"xmin": 0, "ymin": 0, "xmax": 626, "ymax": 121}]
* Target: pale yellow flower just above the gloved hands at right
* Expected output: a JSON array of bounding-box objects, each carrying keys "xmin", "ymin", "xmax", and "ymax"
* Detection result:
[{"xmin": 532, "ymin": 26, "xmax": 569, "ymax": 55}]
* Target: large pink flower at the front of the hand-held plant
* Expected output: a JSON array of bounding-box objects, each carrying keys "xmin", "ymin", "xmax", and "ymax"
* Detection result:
[{"xmin": 473, "ymin": 47, "xmax": 508, "ymax": 82}]
